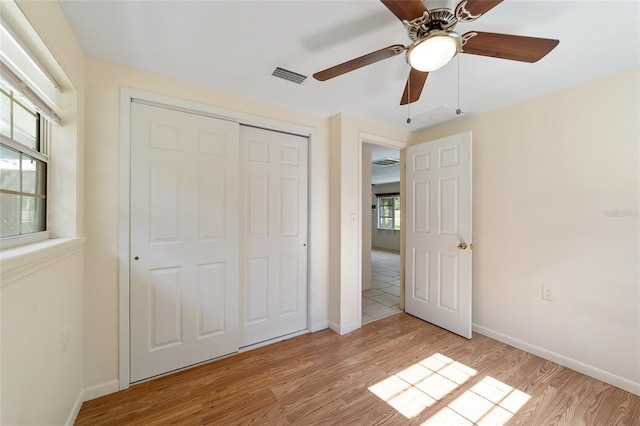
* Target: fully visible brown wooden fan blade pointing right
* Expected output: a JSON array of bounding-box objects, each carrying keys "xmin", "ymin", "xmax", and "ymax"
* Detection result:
[{"xmin": 462, "ymin": 31, "xmax": 560, "ymax": 62}]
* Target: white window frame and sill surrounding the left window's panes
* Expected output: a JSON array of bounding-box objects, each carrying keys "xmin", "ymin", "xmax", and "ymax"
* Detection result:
[{"xmin": 0, "ymin": 0, "xmax": 80, "ymax": 256}]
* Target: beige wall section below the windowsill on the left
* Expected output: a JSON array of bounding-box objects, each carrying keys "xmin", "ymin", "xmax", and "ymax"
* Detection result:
[{"xmin": 0, "ymin": 243, "xmax": 83, "ymax": 425}]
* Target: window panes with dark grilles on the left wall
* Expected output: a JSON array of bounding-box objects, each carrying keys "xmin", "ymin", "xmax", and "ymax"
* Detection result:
[{"xmin": 0, "ymin": 80, "xmax": 49, "ymax": 237}]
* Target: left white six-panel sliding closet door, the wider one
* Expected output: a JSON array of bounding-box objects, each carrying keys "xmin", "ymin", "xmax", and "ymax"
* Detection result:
[{"xmin": 130, "ymin": 103, "xmax": 239, "ymax": 382}]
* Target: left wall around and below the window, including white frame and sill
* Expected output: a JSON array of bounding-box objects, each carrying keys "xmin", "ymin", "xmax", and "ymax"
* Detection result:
[{"xmin": 0, "ymin": 1, "xmax": 85, "ymax": 425}]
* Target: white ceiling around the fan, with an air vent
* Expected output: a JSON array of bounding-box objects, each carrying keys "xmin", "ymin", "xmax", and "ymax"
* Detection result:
[{"xmin": 60, "ymin": 0, "xmax": 640, "ymax": 130}]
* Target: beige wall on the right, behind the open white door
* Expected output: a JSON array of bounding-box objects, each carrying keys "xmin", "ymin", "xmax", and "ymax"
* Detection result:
[{"xmin": 413, "ymin": 68, "xmax": 640, "ymax": 393}]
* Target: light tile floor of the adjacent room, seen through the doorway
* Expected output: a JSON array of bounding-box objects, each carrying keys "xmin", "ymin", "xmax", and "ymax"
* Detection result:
[{"xmin": 362, "ymin": 249, "xmax": 401, "ymax": 324}]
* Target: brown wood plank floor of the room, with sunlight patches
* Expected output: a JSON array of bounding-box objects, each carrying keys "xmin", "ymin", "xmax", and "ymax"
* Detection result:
[{"xmin": 77, "ymin": 314, "xmax": 640, "ymax": 426}]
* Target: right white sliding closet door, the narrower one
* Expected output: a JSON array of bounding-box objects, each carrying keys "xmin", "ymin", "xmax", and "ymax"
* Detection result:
[{"xmin": 240, "ymin": 126, "xmax": 308, "ymax": 346}]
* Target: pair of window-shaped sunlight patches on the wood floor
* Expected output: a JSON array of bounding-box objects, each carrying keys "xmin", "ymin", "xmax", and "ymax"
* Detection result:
[{"xmin": 369, "ymin": 353, "xmax": 531, "ymax": 426}]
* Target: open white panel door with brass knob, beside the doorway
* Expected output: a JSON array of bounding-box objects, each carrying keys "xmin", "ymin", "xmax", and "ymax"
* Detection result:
[{"xmin": 405, "ymin": 132, "xmax": 471, "ymax": 339}]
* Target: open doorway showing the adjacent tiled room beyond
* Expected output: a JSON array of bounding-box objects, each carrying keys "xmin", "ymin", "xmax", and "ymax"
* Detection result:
[{"xmin": 361, "ymin": 143, "xmax": 402, "ymax": 325}]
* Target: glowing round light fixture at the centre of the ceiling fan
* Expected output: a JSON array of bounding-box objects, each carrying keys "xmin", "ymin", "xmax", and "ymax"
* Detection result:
[{"xmin": 407, "ymin": 30, "xmax": 462, "ymax": 72}]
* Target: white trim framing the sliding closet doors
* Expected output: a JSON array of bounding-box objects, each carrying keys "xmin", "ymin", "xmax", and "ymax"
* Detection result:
[{"xmin": 118, "ymin": 87, "xmax": 315, "ymax": 391}]
